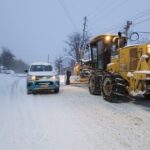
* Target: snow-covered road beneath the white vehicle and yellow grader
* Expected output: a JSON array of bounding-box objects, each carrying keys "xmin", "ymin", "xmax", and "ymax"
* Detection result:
[{"xmin": 0, "ymin": 74, "xmax": 150, "ymax": 150}]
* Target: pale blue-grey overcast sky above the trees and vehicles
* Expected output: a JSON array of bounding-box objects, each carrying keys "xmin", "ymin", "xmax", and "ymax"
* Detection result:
[{"xmin": 0, "ymin": 0, "xmax": 150, "ymax": 63}]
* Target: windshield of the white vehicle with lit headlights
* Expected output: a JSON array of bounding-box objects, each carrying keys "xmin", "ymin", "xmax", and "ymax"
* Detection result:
[{"xmin": 30, "ymin": 65, "xmax": 52, "ymax": 71}]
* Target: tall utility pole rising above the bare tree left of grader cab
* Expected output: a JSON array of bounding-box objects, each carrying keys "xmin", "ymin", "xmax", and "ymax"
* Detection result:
[{"xmin": 80, "ymin": 16, "xmax": 87, "ymax": 59}]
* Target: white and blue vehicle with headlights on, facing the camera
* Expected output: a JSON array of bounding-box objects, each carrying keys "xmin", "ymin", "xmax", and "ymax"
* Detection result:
[{"xmin": 27, "ymin": 62, "xmax": 60, "ymax": 94}]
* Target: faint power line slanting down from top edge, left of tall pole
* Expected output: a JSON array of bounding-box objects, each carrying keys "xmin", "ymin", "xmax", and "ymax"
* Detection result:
[{"xmin": 57, "ymin": 0, "xmax": 78, "ymax": 31}]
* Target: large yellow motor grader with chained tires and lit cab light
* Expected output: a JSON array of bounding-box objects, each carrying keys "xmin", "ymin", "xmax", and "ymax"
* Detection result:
[{"xmin": 89, "ymin": 32, "xmax": 150, "ymax": 102}]
